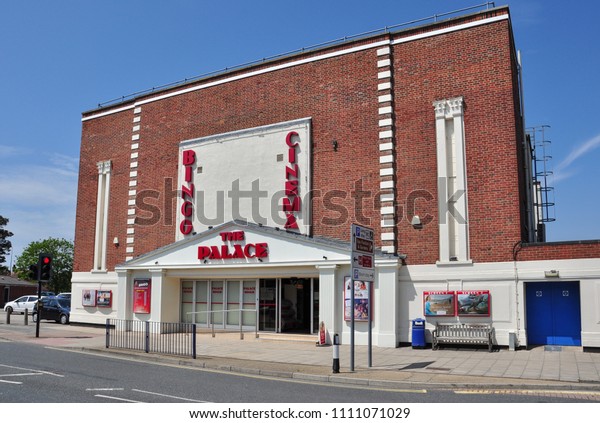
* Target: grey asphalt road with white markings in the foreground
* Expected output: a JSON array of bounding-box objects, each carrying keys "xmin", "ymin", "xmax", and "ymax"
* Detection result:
[{"xmin": 0, "ymin": 342, "xmax": 599, "ymax": 404}]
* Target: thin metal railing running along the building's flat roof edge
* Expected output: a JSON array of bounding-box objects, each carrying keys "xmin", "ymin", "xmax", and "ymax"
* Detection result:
[{"xmin": 95, "ymin": 1, "xmax": 495, "ymax": 111}]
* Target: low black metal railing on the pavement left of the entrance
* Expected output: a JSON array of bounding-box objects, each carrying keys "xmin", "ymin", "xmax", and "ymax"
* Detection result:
[{"xmin": 106, "ymin": 319, "xmax": 196, "ymax": 359}]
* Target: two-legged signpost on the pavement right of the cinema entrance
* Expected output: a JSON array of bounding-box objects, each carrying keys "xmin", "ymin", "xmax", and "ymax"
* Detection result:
[{"xmin": 350, "ymin": 224, "xmax": 375, "ymax": 372}]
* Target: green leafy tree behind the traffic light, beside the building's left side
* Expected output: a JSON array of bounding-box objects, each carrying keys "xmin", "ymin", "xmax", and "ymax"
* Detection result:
[{"xmin": 15, "ymin": 238, "xmax": 73, "ymax": 294}]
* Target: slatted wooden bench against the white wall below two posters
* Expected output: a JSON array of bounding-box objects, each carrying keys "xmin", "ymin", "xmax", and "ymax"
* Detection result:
[{"xmin": 432, "ymin": 323, "xmax": 494, "ymax": 352}]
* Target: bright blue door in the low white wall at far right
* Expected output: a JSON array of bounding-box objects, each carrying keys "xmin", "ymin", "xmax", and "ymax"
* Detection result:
[{"xmin": 525, "ymin": 282, "xmax": 581, "ymax": 345}]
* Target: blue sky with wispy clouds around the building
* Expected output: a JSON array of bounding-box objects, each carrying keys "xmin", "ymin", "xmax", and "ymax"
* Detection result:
[{"xmin": 0, "ymin": 0, "xmax": 600, "ymax": 264}]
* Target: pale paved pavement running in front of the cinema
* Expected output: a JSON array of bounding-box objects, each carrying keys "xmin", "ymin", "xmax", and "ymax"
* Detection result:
[{"xmin": 0, "ymin": 312, "xmax": 600, "ymax": 394}]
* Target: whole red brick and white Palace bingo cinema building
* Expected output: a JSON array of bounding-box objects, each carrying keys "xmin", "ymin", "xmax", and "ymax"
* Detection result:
[{"xmin": 71, "ymin": 7, "xmax": 600, "ymax": 347}]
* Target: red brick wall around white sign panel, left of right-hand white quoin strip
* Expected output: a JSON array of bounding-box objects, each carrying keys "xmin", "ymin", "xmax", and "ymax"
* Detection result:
[{"xmin": 75, "ymin": 50, "xmax": 379, "ymax": 271}]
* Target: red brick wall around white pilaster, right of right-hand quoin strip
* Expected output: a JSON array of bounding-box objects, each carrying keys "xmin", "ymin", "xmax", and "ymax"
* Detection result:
[{"xmin": 394, "ymin": 21, "xmax": 521, "ymax": 264}]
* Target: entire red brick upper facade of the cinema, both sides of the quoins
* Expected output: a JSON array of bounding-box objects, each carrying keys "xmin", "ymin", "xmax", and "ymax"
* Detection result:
[{"xmin": 74, "ymin": 8, "xmax": 597, "ymax": 272}]
